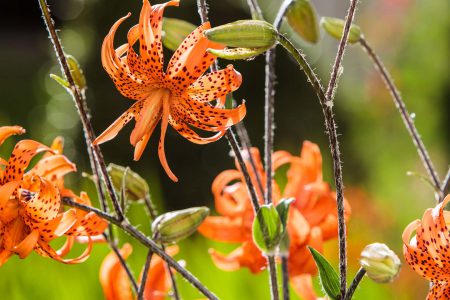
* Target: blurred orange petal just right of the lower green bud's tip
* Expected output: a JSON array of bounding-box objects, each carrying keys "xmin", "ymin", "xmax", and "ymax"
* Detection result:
[{"xmin": 198, "ymin": 217, "xmax": 246, "ymax": 243}]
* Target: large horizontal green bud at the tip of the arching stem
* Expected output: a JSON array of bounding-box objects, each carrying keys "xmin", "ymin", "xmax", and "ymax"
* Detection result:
[{"xmin": 204, "ymin": 20, "xmax": 278, "ymax": 48}]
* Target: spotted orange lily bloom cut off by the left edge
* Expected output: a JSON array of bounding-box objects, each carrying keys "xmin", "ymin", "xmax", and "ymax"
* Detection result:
[{"xmin": 0, "ymin": 126, "xmax": 107, "ymax": 265}]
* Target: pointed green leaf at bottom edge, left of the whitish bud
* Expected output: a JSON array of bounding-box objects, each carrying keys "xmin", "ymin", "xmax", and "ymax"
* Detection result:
[{"xmin": 308, "ymin": 246, "xmax": 341, "ymax": 300}]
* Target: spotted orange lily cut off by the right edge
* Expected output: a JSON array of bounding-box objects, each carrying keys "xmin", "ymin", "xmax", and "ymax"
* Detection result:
[{"xmin": 402, "ymin": 195, "xmax": 450, "ymax": 300}]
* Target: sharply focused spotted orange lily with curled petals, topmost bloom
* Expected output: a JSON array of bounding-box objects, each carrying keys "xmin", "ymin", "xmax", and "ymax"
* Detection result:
[{"xmin": 94, "ymin": 0, "xmax": 246, "ymax": 181}]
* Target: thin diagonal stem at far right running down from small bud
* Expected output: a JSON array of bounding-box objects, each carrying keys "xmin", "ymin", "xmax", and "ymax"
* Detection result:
[{"xmin": 359, "ymin": 37, "xmax": 443, "ymax": 199}]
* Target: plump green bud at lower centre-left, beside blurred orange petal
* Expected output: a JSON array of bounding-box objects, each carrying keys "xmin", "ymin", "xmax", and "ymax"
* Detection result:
[{"xmin": 152, "ymin": 206, "xmax": 209, "ymax": 244}]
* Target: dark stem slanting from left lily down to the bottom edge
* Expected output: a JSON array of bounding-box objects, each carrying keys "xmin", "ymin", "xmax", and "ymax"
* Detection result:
[{"xmin": 62, "ymin": 197, "xmax": 218, "ymax": 299}]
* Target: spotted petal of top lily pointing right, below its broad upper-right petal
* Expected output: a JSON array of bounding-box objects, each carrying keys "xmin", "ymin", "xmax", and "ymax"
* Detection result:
[{"xmin": 187, "ymin": 65, "xmax": 242, "ymax": 102}]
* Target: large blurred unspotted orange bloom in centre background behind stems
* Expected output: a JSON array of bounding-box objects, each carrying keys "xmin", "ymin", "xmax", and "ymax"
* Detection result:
[{"xmin": 199, "ymin": 142, "xmax": 350, "ymax": 299}]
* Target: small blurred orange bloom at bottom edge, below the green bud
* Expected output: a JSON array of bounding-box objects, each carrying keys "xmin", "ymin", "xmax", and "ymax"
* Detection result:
[{"xmin": 100, "ymin": 243, "xmax": 179, "ymax": 300}]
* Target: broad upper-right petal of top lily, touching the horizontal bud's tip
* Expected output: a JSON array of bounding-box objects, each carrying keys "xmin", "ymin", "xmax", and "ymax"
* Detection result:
[{"xmin": 166, "ymin": 22, "xmax": 224, "ymax": 91}]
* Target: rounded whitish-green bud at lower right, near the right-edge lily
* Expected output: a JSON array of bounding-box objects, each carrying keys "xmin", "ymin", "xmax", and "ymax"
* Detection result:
[{"xmin": 359, "ymin": 243, "xmax": 401, "ymax": 283}]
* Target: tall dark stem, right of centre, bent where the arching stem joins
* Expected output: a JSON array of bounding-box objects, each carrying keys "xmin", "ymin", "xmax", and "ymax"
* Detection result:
[{"xmin": 325, "ymin": 0, "xmax": 358, "ymax": 298}]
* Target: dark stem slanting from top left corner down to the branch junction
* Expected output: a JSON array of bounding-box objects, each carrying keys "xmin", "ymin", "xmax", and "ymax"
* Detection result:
[{"xmin": 39, "ymin": 0, "xmax": 124, "ymax": 223}]
